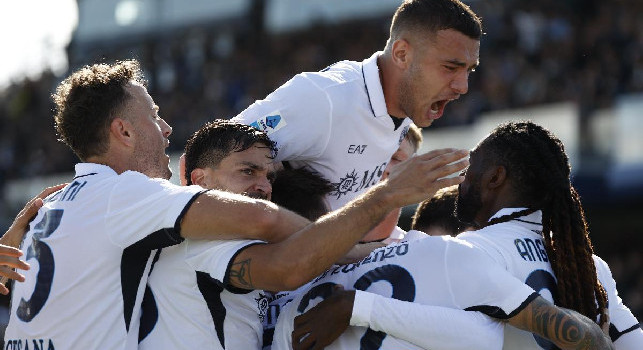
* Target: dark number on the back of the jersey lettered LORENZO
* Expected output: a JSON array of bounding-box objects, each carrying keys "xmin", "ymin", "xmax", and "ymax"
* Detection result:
[{"xmin": 297, "ymin": 265, "xmax": 415, "ymax": 350}]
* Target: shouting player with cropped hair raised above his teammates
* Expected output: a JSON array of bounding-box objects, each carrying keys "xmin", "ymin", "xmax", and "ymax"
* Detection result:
[{"xmin": 234, "ymin": 0, "xmax": 482, "ymax": 209}]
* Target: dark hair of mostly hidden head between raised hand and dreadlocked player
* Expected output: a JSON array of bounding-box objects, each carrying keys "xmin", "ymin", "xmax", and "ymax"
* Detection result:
[{"xmin": 411, "ymin": 185, "xmax": 462, "ymax": 237}]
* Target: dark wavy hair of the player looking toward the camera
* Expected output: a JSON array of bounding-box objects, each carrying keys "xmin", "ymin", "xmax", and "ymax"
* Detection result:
[{"xmin": 184, "ymin": 119, "xmax": 276, "ymax": 185}]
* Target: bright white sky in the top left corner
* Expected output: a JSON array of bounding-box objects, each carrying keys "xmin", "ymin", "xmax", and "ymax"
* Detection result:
[{"xmin": 0, "ymin": 0, "xmax": 78, "ymax": 89}]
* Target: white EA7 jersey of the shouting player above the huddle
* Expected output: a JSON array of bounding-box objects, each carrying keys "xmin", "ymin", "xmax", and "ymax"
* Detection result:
[{"xmin": 232, "ymin": 52, "xmax": 411, "ymax": 210}]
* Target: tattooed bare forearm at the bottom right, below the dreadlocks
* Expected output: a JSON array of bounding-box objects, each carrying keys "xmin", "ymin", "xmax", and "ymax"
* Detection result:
[{"xmin": 508, "ymin": 297, "xmax": 614, "ymax": 350}]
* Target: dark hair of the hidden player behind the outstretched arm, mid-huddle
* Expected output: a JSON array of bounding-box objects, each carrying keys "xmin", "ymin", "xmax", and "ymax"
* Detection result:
[{"xmin": 272, "ymin": 168, "xmax": 334, "ymax": 221}]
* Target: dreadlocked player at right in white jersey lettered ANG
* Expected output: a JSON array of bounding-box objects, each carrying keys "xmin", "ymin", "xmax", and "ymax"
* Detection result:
[{"xmin": 456, "ymin": 122, "xmax": 643, "ymax": 349}]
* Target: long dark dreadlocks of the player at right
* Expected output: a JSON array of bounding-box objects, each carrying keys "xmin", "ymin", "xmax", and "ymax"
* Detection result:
[{"xmin": 477, "ymin": 121, "xmax": 607, "ymax": 325}]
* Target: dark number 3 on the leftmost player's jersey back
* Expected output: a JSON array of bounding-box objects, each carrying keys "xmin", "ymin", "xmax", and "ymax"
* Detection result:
[{"xmin": 16, "ymin": 209, "xmax": 63, "ymax": 322}]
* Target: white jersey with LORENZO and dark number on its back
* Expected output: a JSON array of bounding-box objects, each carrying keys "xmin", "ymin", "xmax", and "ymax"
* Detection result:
[{"xmin": 273, "ymin": 237, "xmax": 537, "ymax": 350}]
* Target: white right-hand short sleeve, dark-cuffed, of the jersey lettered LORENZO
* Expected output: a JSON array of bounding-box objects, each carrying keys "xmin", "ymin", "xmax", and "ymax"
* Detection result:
[{"xmin": 445, "ymin": 240, "xmax": 538, "ymax": 319}]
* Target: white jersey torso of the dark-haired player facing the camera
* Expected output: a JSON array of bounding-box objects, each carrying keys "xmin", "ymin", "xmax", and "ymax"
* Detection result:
[{"xmin": 139, "ymin": 239, "xmax": 268, "ymax": 350}]
